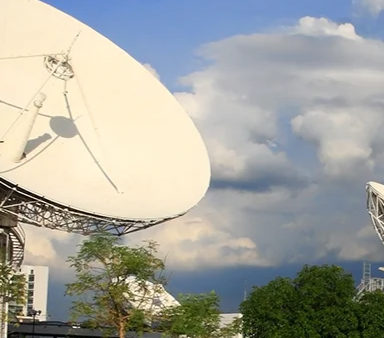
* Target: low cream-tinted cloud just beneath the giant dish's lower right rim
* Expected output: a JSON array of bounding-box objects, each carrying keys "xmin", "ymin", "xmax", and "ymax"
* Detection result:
[{"xmin": 128, "ymin": 216, "xmax": 269, "ymax": 270}]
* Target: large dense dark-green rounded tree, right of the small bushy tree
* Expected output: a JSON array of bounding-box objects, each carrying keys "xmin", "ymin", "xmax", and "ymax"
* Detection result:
[{"xmin": 240, "ymin": 265, "xmax": 359, "ymax": 338}]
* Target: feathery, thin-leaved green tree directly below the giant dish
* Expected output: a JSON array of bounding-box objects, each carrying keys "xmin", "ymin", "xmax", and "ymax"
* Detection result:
[{"xmin": 66, "ymin": 234, "xmax": 164, "ymax": 338}]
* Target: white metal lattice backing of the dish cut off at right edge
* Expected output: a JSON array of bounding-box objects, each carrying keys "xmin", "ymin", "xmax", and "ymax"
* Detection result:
[{"xmin": 366, "ymin": 184, "xmax": 384, "ymax": 244}]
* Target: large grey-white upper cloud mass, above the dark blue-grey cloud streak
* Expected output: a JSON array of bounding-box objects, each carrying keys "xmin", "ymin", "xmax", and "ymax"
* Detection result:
[{"xmin": 178, "ymin": 17, "xmax": 384, "ymax": 185}]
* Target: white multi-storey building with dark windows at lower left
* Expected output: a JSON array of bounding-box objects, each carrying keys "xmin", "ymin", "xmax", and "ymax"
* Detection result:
[{"xmin": 10, "ymin": 265, "xmax": 48, "ymax": 321}]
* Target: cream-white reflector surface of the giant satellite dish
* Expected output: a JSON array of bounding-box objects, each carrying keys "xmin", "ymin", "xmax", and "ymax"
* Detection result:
[{"xmin": 0, "ymin": 0, "xmax": 210, "ymax": 232}]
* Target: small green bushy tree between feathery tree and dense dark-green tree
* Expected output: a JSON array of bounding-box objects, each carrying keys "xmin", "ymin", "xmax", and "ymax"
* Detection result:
[{"xmin": 163, "ymin": 291, "xmax": 220, "ymax": 338}]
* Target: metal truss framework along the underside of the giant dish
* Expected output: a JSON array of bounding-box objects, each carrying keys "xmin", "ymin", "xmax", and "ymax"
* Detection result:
[{"xmin": 0, "ymin": 178, "xmax": 181, "ymax": 236}]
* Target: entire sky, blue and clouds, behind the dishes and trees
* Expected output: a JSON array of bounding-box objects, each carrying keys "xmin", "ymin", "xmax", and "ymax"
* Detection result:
[{"xmin": 18, "ymin": 0, "xmax": 384, "ymax": 320}]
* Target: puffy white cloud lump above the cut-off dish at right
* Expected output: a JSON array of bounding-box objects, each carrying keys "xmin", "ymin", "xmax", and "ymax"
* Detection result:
[{"xmin": 292, "ymin": 107, "xmax": 380, "ymax": 177}]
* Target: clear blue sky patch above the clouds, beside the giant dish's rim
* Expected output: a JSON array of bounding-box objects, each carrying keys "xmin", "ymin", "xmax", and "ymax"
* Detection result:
[{"xmin": 45, "ymin": 0, "xmax": 351, "ymax": 89}]
